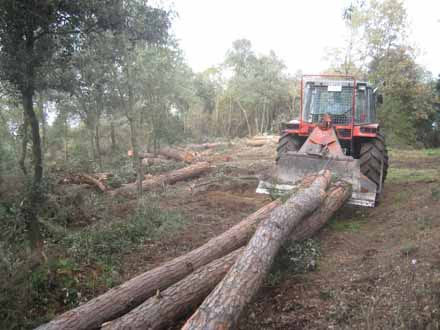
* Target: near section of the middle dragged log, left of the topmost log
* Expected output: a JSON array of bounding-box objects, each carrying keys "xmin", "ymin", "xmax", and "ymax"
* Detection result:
[{"xmin": 101, "ymin": 248, "xmax": 243, "ymax": 330}]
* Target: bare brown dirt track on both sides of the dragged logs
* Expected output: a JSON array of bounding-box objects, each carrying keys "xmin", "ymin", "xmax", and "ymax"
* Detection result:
[{"xmin": 118, "ymin": 143, "xmax": 440, "ymax": 329}]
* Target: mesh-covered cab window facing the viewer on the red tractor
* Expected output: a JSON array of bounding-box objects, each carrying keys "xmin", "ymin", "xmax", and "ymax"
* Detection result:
[{"xmin": 303, "ymin": 84, "xmax": 353, "ymax": 124}]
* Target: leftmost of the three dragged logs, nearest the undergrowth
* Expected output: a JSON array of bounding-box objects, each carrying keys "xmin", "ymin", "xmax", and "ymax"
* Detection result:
[{"xmin": 38, "ymin": 201, "xmax": 279, "ymax": 330}]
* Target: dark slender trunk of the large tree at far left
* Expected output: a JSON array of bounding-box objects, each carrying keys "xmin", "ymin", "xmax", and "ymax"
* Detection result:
[{"xmin": 22, "ymin": 83, "xmax": 43, "ymax": 252}]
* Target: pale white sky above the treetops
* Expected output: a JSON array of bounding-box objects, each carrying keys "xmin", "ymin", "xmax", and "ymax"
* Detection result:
[{"xmin": 173, "ymin": 0, "xmax": 440, "ymax": 76}]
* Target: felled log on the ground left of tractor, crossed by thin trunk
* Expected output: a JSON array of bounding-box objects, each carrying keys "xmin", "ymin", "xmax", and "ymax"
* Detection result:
[{"xmin": 112, "ymin": 162, "xmax": 211, "ymax": 195}]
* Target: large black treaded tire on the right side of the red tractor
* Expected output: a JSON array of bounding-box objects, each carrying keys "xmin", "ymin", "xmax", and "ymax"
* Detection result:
[{"xmin": 359, "ymin": 133, "xmax": 388, "ymax": 189}]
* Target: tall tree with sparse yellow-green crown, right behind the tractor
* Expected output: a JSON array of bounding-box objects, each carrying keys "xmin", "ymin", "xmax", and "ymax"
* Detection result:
[{"xmin": 331, "ymin": 0, "xmax": 434, "ymax": 145}]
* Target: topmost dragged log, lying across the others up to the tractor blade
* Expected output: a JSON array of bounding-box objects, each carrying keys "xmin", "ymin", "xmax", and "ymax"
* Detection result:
[{"xmin": 182, "ymin": 171, "xmax": 330, "ymax": 330}]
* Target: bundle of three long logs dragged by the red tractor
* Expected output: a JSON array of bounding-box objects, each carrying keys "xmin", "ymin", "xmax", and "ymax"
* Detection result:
[{"xmin": 38, "ymin": 172, "xmax": 351, "ymax": 330}]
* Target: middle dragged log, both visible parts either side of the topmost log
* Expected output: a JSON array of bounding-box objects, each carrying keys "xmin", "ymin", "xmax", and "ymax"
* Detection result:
[{"xmin": 102, "ymin": 183, "xmax": 351, "ymax": 330}]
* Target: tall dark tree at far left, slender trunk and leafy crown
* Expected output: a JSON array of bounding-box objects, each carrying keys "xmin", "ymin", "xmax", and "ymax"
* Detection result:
[{"xmin": 0, "ymin": 0, "xmax": 169, "ymax": 249}]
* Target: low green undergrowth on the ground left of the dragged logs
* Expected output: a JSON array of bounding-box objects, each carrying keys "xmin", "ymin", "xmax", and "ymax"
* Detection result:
[{"xmin": 0, "ymin": 198, "xmax": 185, "ymax": 330}]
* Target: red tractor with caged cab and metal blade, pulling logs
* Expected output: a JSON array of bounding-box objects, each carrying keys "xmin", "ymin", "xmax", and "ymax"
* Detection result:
[{"xmin": 259, "ymin": 75, "xmax": 388, "ymax": 207}]
